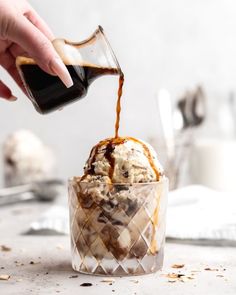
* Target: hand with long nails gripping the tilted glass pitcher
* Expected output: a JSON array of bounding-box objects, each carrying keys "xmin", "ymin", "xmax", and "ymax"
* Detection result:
[{"xmin": 0, "ymin": 0, "xmax": 73, "ymax": 100}]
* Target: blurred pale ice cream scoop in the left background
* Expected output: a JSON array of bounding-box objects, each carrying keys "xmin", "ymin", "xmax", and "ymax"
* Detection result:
[{"xmin": 3, "ymin": 129, "xmax": 56, "ymax": 186}]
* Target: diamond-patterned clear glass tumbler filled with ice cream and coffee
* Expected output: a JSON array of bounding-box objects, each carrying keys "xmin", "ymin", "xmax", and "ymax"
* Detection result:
[{"xmin": 69, "ymin": 177, "xmax": 168, "ymax": 276}]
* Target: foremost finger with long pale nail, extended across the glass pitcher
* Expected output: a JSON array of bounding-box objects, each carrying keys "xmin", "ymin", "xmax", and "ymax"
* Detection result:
[{"xmin": 8, "ymin": 16, "xmax": 73, "ymax": 87}]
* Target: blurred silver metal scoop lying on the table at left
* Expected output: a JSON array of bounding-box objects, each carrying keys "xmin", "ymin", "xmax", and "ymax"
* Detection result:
[{"xmin": 0, "ymin": 179, "xmax": 63, "ymax": 206}]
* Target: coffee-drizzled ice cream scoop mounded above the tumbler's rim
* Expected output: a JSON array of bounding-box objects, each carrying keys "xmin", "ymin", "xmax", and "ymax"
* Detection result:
[{"xmin": 81, "ymin": 137, "xmax": 163, "ymax": 183}]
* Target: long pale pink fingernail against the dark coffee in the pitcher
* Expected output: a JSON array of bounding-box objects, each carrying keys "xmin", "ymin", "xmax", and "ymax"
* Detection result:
[{"xmin": 50, "ymin": 57, "xmax": 74, "ymax": 88}]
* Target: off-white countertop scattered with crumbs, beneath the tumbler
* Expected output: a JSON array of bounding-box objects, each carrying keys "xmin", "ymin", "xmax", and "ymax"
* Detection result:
[{"xmin": 0, "ymin": 203, "xmax": 236, "ymax": 295}]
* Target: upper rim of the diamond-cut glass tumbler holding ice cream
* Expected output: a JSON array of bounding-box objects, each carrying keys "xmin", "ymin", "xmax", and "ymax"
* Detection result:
[{"xmin": 68, "ymin": 176, "xmax": 169, "ymax": 186}]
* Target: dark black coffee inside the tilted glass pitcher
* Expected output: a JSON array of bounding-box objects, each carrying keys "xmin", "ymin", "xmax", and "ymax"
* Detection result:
[{"xmin": 20, "ymin": 64, "xmax": 118, "ymax": 114}]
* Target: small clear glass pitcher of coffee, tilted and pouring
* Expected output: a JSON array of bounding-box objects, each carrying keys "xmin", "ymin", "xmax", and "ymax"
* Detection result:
[{"xmin": 16, "ymin": 26, "xmax": 122, "ymax": 114}]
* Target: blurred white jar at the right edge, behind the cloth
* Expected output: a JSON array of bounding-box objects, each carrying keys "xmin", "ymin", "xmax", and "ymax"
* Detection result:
[{"xmin": 189, "ymin": 139, "xmax": 236, "ymax": 192}]
